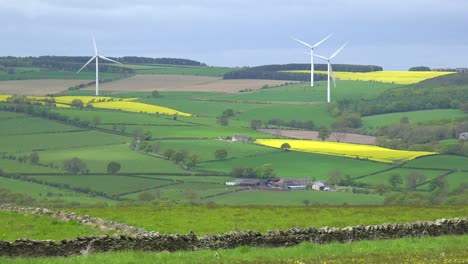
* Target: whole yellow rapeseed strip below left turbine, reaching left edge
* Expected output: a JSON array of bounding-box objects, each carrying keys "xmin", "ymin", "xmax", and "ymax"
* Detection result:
[{"xmin": 0, "ymin": 95, "xmax": 191, "ymax": 116}]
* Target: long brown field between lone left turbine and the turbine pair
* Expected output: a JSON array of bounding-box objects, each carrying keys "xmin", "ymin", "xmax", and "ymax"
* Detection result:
[{"xmin": 94, "ymin": 74, "xmax": 288, "ymax": 93}]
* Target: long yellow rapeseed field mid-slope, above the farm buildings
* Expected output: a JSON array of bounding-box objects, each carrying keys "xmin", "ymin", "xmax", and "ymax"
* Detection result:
[{"xmin": 255, "ymin": 139, "xmax": 437, "ymax": 163}]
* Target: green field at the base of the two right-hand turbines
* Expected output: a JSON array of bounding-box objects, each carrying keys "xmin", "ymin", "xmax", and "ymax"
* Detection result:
[{"xmin": 205, "ymin": 81, "xmax": 398, "ymax": 102}]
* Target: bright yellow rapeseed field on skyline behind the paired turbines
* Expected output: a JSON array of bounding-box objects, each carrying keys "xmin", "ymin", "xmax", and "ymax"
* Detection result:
[{"xmin": 285, "ymin": 71, "xmax": 454, "ymax": 84}]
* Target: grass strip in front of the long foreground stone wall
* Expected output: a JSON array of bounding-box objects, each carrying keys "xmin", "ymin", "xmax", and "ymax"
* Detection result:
[{"xmin": 0, "ymin": 236, "xmax": 468, "ymax": 264}]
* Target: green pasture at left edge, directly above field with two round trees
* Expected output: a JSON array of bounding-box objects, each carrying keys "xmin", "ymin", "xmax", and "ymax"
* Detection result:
[{"xmin": 0, "ymin": 131, "xmax": 130, "ymax": 156}]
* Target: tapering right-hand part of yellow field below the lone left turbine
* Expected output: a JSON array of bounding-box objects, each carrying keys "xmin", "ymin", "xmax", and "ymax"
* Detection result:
[{"xmin": 93, "ymin": 101, "xmax": 191, "ymax": 116}]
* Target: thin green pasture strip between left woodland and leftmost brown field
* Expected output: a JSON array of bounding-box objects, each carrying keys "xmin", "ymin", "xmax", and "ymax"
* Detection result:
[{"xmin": 0, "ymin": 70, "xmax": 122, "ymax": 81}]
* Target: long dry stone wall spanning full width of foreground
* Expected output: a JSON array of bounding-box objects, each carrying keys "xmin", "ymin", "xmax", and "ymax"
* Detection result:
[{"xmin": 0, "ymin": 218, "xmax": 468, "ymax": 257}]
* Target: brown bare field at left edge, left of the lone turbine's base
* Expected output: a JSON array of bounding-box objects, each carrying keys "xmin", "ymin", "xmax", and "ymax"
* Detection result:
[{"xmin": 0, "ymin": 80, "xmax": 89, "ymax": 95}]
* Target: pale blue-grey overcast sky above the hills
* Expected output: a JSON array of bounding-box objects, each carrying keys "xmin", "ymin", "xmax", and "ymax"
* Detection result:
[{"xmin": 0, "ymin": 0, "xmax": 468, "ymax": 70}]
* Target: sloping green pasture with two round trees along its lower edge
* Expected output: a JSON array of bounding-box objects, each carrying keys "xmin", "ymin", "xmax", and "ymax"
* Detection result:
[{"xmin": 34, "ymin": 144, "xmax": 187, "ymax": 173}]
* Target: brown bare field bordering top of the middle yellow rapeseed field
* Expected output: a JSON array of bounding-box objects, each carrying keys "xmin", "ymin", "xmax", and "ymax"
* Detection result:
[{"xmin": 258, "ymin": 129, "xmax": 376, "ymax": 145}]
